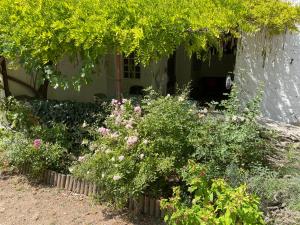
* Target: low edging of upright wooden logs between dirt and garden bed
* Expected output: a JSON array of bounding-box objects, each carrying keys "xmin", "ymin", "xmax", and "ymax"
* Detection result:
[{"xmin": 22, "ymin": 169, "xmax": 164, "ymax": 219}]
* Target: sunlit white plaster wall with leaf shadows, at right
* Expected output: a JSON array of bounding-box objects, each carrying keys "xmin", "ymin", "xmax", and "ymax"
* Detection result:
[{"xmin": 235, "ymin": 27, "xmax": 300, "ymax": 123}]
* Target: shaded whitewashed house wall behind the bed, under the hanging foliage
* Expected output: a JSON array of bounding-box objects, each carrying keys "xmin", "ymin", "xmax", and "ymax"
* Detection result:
[{"xmin": 8, "ymin": 49, "xmax": 191, "ymax": 102}]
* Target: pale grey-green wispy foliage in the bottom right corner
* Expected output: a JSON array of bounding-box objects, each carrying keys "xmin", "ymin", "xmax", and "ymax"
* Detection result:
[{"xmin": 244, "ymin": 144, "xmax": 300, "ymax": 225}]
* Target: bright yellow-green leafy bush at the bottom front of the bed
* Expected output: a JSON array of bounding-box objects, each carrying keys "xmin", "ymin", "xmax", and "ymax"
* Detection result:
[{"xmin": 162, "ymin": 161, "xmax": 265, "ymax": 225}]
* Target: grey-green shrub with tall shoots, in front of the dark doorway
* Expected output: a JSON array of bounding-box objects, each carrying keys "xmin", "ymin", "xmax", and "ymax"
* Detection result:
[{"xmin": 188, "ymin": 88, "xmax": 275, "ymax": 179}]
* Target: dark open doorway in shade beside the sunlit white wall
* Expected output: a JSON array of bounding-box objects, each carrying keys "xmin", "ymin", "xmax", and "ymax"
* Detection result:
[{"xmin": 191, "ymin": 39, "xmax": 237, "ymax": 103}]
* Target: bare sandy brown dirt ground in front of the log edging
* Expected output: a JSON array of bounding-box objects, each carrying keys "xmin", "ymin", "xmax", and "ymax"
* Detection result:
[{"xmin": 0, "ymin": 176, "xmax": 159, "ymax": 225}]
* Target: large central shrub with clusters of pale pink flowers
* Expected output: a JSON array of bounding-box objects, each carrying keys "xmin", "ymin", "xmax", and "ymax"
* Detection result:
[{"xmin": 74, "ymin": 91, "xmax": 197, "ymax": 204}]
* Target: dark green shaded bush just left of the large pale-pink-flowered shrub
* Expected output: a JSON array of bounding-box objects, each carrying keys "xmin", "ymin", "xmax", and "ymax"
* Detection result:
[{"xmin": 29, "ymin": 100, "xmax": 108, "ymax": 155}]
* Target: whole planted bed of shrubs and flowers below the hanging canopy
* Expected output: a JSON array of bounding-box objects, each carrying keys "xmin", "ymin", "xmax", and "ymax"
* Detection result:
[{"xmin": 0, "ymin": 85, "xmax": 300, "ymax": 224}]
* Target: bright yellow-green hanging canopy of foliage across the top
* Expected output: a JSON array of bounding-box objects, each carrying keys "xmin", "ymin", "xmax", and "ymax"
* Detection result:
[{"xmin": 0, "ymin": 0, "xmax": 300, "ymax": 87}]
